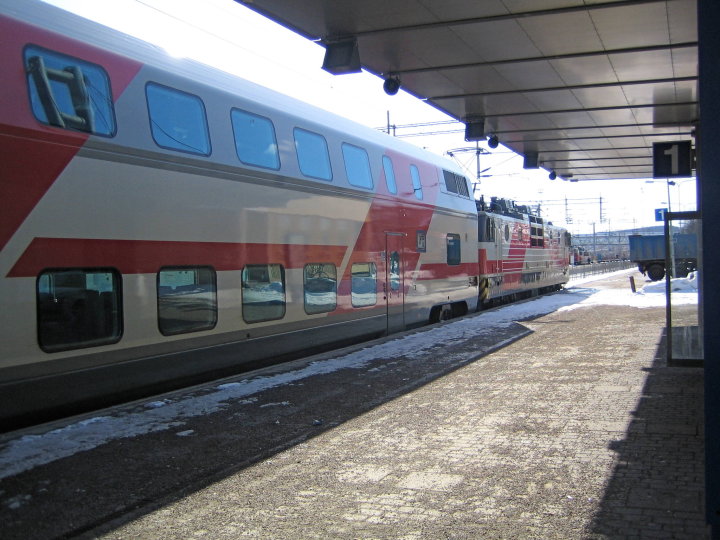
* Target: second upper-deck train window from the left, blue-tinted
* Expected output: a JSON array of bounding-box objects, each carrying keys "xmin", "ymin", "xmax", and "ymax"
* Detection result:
[{"xmin": 145, "ymin": 83, "xmax": 210, "ymax": 156}]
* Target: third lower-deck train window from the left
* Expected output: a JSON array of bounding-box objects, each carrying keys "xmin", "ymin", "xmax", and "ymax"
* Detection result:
[{"xmin": 242, "ymin": 264, "xmax": 285, "ymax": 323}]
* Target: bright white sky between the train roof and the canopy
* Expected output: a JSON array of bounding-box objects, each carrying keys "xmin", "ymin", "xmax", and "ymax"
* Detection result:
[{"xmin": 45, "ymin": 0, "xmax": 695, "ymax": 233}]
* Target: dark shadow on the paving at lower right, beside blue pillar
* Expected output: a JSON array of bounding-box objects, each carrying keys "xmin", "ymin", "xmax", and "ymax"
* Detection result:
[{"xmin": 592, "ymin": 326, "xmax": 707, "ymax": 539}]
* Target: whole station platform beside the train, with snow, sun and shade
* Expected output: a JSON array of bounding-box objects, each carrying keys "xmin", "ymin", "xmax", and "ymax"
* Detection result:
[{"xmin": 0, "ymin": 272, "xmax": 707, "ymax": 539}]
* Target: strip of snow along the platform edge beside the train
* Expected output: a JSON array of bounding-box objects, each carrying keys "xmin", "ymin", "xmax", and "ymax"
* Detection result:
[{"xmin": 0, "ymin": 270, "xmax": 697, "ymax": 479}]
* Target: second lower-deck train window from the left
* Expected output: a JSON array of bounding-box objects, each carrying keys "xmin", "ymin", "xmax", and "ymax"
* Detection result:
[{"xmin": 157, "ymin": 266, "xmax": 217, "ymax": 336}]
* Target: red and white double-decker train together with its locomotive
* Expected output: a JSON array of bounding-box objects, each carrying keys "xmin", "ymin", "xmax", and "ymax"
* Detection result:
[{"xmin": 0, "ymin": 0, "xmax": 567, "ymax": 429}]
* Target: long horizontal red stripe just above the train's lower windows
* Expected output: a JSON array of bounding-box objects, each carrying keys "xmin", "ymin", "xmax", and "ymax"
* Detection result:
[{"xmin": 7, "ymin": 238, "xmax": 348, "ymax": 277}]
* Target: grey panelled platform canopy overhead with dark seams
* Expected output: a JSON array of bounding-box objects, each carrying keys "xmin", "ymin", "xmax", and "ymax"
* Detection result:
[{"xmin": 237, "ymin": 0, "xmax": 698, "ymax": 180}]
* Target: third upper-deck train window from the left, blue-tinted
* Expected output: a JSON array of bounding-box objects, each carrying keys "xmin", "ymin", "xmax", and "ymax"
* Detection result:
[{"xmin": 230, "ymin": 109, "xmax": 280, "ymax": 170}]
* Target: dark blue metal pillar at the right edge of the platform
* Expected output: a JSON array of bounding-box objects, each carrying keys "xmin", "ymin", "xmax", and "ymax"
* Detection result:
[{"xmin": 696, "ymin": 0, "xmax": 720, "ymax": 538}]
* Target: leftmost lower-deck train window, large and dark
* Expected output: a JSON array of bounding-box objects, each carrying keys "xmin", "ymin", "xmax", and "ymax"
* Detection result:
[{"xmin": 37, "ymin": 269, "xmax": 122, "ymax": 352}]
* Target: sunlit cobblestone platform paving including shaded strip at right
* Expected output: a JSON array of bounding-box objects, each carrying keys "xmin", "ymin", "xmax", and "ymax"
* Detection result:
[{"xmin": 98, "ymin": 277, "xmax": 705, "ymax": 539}]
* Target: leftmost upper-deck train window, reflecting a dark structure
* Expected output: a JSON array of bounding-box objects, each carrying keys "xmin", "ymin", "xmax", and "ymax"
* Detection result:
[{"xmin": 24, "ymin": 46, "xmax": 115, "ymax": 137}]
